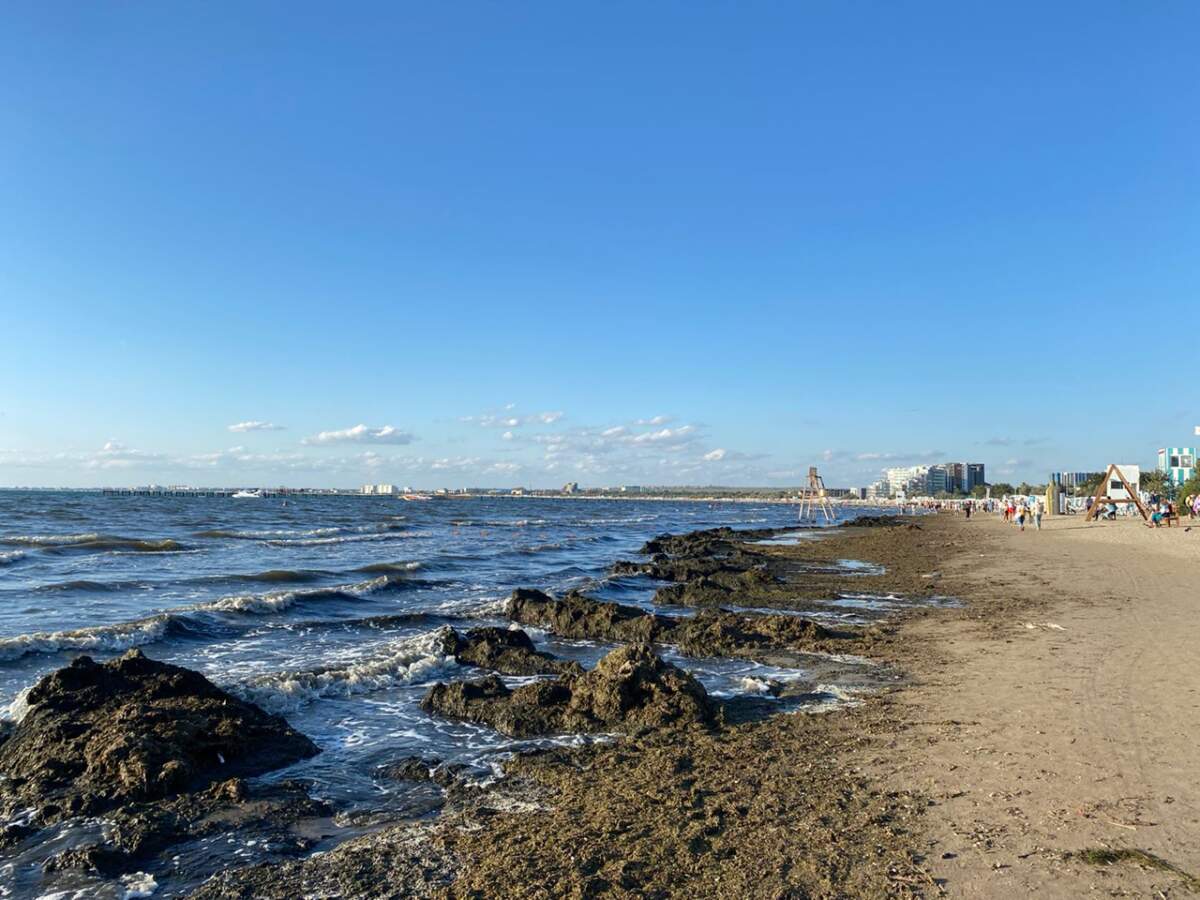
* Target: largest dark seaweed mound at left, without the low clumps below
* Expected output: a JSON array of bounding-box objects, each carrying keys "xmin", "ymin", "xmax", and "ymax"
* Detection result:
[{"xmin": 0, "ymin": 650, "xmax": 317, "ymax": 818}]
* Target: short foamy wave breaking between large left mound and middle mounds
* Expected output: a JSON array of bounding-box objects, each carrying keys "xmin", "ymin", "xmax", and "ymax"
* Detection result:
[{"xmin": 229, "ymin": 629, "xmax": 457, "ymax": 713}]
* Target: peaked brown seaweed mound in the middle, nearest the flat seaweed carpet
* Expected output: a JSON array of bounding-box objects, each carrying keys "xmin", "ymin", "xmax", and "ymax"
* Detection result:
[{"xmin": 421, "ymin": 643, "xmax": 714, "ymax": 737}]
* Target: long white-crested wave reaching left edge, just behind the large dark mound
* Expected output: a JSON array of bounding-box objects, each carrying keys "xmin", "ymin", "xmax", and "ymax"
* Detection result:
[{"xmin": 0, "ymin": 575, "xmax": 403, "ymax": 662}]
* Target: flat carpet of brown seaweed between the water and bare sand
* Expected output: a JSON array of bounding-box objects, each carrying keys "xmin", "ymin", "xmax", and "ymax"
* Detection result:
[{"xmin": 189, "ymin": 518, "xmax": 955, "ymax": 898}]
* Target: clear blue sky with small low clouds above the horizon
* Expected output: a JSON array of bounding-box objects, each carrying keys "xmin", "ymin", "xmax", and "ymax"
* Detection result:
[{"xmin": 0, "ymin": 2, "xmax": 1200, "ymax": 486}]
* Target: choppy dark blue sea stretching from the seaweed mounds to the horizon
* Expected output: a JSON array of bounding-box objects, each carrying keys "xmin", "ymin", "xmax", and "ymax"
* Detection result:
[{"xmin": 0, "ymin": 491, "xmax": 868, "ymax": 895}]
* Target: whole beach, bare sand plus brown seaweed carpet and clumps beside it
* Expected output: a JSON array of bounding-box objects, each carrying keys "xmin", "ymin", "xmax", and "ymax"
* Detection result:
[{"xmin": 7, "ymin": 515, "xmax": 1200, "ymax": 899}]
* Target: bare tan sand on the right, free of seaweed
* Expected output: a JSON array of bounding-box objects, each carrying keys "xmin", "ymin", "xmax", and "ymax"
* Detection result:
[{"xmin": 865, "ymin": 516, "xmax": 1200, "ymax": 898}]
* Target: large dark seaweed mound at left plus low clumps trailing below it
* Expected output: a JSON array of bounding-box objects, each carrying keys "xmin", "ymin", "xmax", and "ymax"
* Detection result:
[{"xmin": 0, "ymin": 650, "xmax": 330, "ymax": 871}]
